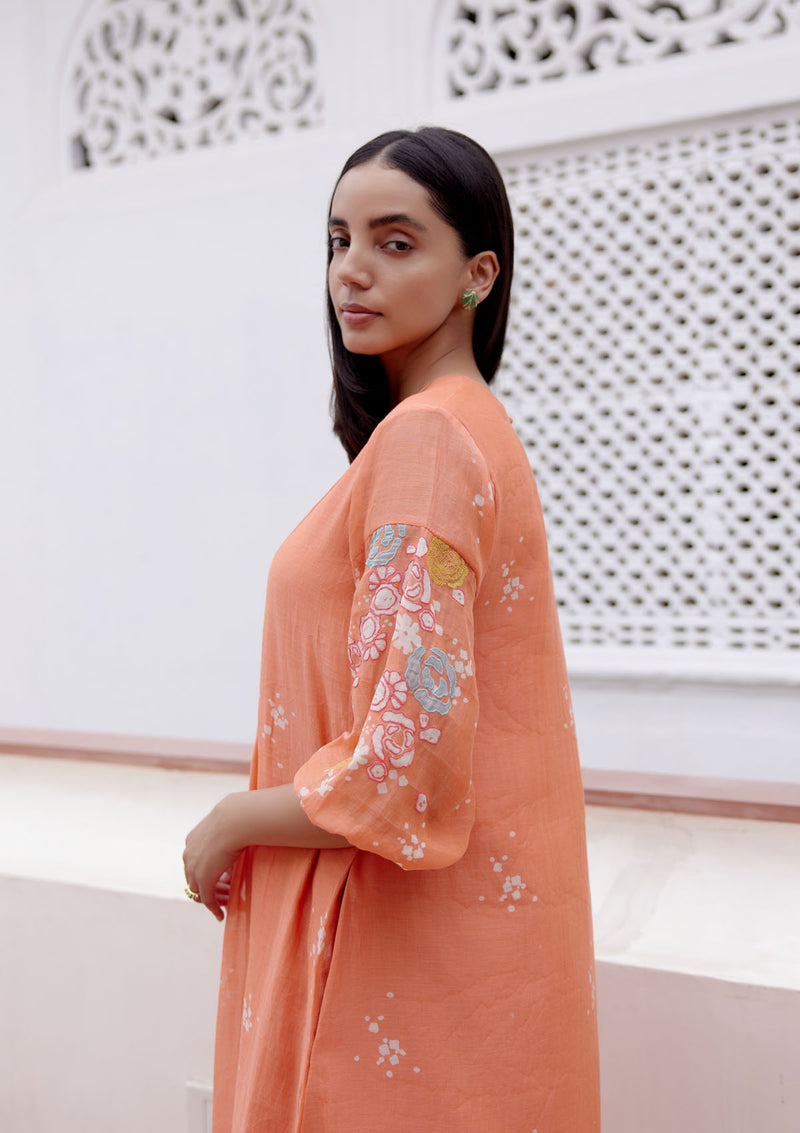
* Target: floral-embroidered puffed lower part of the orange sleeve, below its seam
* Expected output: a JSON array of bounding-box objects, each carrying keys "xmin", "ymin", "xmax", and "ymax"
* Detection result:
[{"xmin": 295, "ymin": 523, "xmax": 478, "ymax": 869}]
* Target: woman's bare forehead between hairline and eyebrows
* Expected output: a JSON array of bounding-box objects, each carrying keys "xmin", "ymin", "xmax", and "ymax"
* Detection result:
[{"xmin": 331, "ymin": 161, "xmax": 435, "ymax": 228}]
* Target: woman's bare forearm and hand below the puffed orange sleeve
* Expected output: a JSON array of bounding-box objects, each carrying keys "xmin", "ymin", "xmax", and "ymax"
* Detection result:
[{"xmin": 184, "ymin": 783, "xmax": 350, "ymax": 920}]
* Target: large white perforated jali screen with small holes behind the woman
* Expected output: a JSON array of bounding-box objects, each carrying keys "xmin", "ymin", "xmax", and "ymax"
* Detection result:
[{"xmin": 499, "ymin": 108, "xmax": 800, "ymax": 653}]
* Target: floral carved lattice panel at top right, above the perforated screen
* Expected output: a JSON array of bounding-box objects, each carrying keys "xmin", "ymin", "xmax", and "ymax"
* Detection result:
[{"xmin": 440, "ymin": 0, "xmax": 800, "ymax": 99}]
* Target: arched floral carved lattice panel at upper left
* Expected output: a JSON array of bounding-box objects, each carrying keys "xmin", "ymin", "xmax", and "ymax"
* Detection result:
[{"xmin": 67, "ymin": 0, "xmax": 322, "ymax": 168}]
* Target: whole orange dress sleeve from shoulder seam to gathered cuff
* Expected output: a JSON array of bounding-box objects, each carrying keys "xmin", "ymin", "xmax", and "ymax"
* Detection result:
[{"xmin": 295, "ymin": 410, "xmax": 493, "ymax": 869}]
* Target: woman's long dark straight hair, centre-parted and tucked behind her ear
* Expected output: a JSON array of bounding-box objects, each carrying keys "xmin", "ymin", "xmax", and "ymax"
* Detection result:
[{"xmin": 327, "ymin": 126, "xmax": 513, "ymax": 461}]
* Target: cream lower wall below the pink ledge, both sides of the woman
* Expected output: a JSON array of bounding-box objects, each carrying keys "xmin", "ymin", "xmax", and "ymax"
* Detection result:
[{"xmin": 0, "ymin": 756, "xmax": 800, "ymax": 1133}]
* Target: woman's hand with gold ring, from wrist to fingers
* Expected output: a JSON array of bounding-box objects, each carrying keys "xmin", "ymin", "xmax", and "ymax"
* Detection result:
[{"xmin": 184, "ymin": 792, "xmax": 246, "ymax": 920}]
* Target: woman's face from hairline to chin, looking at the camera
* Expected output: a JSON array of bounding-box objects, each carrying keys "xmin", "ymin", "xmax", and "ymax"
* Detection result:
[{"xmin": 327, "ymin": 160, "xmax": 469, "ymax": 361}]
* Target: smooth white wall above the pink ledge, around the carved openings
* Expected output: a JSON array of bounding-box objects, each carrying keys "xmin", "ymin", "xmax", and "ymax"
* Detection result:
[{"xmin": 0, "ymin": 0, "xmax": 800, "ymax": 780}]
